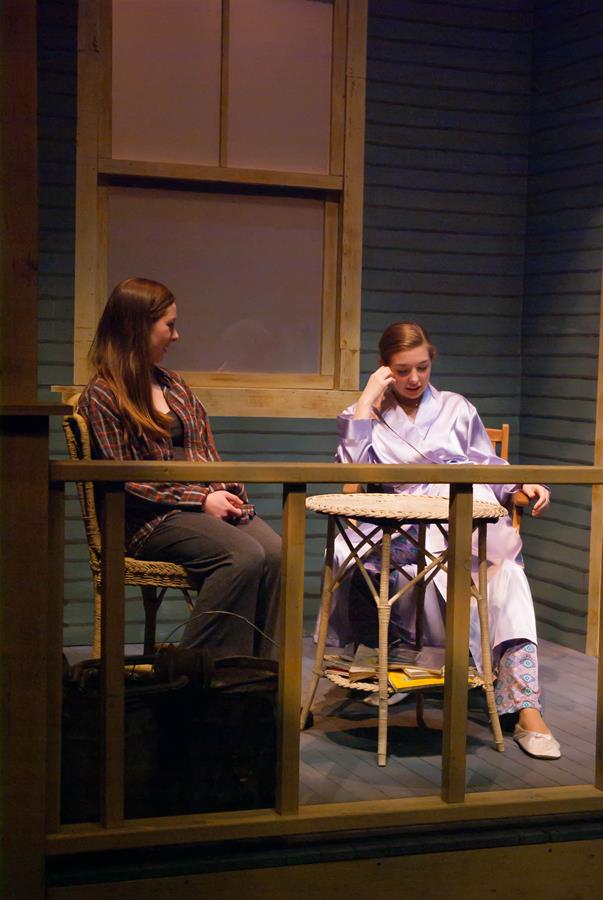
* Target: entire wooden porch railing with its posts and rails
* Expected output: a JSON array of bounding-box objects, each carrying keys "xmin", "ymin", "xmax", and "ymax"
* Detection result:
[{"xmin": 47, "ymin": 461, "xmax": 603, "ymax": 854}]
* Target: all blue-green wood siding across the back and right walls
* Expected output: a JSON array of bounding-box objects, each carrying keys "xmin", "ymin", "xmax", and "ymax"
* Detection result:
[{"xmin": 39, "ymin": 0, "xmax": 603, "ymax": 648}]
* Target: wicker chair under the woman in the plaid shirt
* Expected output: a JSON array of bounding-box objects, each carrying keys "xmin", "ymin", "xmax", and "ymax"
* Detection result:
[{"xmin": 63, "ymin": 413, "xmax": 197, "ymax": 657}]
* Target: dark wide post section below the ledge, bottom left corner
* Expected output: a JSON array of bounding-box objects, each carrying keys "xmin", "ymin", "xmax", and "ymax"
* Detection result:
[{"xmin": 0, "ymin": 412, "xmax": 48, "ymax": 900}]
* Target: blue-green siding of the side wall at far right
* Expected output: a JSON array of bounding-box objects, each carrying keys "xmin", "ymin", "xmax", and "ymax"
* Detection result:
[{"xmin": 521, "ymin": 0, "xmax": 603, "ymax": 649}]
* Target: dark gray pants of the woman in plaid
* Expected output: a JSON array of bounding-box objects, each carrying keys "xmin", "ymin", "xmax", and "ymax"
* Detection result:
[{"xmin": 138, "ymin": 512, "xmax": 281, "ymax": 658}]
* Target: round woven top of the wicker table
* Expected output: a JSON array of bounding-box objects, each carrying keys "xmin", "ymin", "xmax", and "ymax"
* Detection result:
[{"xmin": 306, "ymin": 494, "xmax": 508, "ymax": 522}]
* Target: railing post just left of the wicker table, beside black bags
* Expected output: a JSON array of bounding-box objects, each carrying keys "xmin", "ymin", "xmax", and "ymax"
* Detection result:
[{"xmin": 276, "ymin": 484, "xmax": 306, "ymax": 815}]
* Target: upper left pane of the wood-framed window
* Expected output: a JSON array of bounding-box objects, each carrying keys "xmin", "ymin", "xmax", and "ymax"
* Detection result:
[{"xmin": 112, "ymin": 0, "xmax": 221, "ymax": 165}]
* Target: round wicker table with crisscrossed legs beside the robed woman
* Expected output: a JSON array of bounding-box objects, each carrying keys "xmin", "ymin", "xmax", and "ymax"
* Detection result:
[{"xmin": 300, "ymin": 493, "xmax": 507, "ymax": 766}]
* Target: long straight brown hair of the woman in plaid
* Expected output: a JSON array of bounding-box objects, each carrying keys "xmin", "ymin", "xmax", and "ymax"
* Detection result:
[{"xmin": 90, "ymin": 278, "xmax": 175, "ymax": 437}]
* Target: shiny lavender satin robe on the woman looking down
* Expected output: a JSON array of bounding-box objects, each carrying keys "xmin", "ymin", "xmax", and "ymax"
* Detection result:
[{"xmin": 328, "ymin": 385, "xmax": 536, "ymax": 667}]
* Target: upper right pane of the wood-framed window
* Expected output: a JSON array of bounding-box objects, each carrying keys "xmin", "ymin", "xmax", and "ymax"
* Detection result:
[{"xmin": 228, "ymin": 0, "xmax": 333, "ymax": 172}]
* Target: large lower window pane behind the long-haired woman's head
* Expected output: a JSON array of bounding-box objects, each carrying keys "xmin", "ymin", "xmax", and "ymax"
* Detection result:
[{"xmin": 109, "ymin": 188, "xmax": 323, "ymax": 373}]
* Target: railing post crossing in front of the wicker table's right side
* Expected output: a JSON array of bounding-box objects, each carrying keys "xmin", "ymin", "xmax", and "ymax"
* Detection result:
[{"xmin": 442, "ymin": 484, "xmax": 473, "ymax": 803}]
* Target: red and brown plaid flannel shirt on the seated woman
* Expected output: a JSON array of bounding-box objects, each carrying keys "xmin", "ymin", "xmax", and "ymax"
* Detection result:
[{"xmin": 77, "ymin": 366, "xmax": 255, "ymax": 555}]
